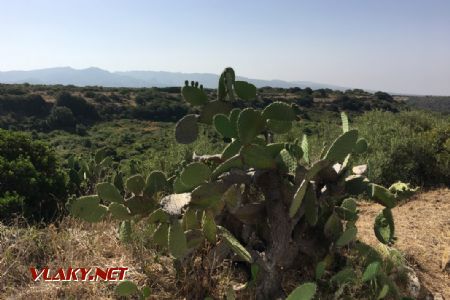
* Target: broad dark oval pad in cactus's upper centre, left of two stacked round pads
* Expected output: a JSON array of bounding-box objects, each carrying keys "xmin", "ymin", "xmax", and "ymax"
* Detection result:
[{"xmin": 237, "ymin": 108, "xmax": 266, "ymax": 144}]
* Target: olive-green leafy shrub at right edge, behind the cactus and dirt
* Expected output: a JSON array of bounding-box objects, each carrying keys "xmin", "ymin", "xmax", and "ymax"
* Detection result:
[{"xmin": 355, "ymin": 111, "xmax": 450, "ymax": 186}]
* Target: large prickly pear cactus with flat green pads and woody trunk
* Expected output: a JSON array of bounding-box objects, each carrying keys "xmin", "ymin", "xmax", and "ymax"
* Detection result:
[{"xmin": 71, "ymin": 68, "xmax": 414, "ymax": 299}]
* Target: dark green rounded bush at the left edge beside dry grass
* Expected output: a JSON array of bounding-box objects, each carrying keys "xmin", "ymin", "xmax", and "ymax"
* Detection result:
[{"xmin": 0, "ymin": 130, "xmax": 66, "ymax": 221}]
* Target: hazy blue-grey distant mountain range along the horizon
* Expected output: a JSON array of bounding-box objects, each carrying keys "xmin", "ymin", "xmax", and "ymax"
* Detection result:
[{"xmin": 0, "ymin": 67, "xmax": 347, "ymax": 90}]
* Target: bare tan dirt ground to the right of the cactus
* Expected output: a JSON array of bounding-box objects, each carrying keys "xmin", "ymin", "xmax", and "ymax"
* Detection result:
[{"xmin": 358, "ymin": 189, "xmax": 450, "ymax": 300}]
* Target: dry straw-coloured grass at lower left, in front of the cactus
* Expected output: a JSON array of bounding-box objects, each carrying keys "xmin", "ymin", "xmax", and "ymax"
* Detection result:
[{"xmin": 0, "ymin": 218, "xmax": 246, "ymax": 299}]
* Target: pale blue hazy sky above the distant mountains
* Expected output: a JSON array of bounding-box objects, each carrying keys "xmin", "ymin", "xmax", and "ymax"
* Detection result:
[{"xmin": 0, "ymin": 0, "xmax": 450, "ymax": 95}]
